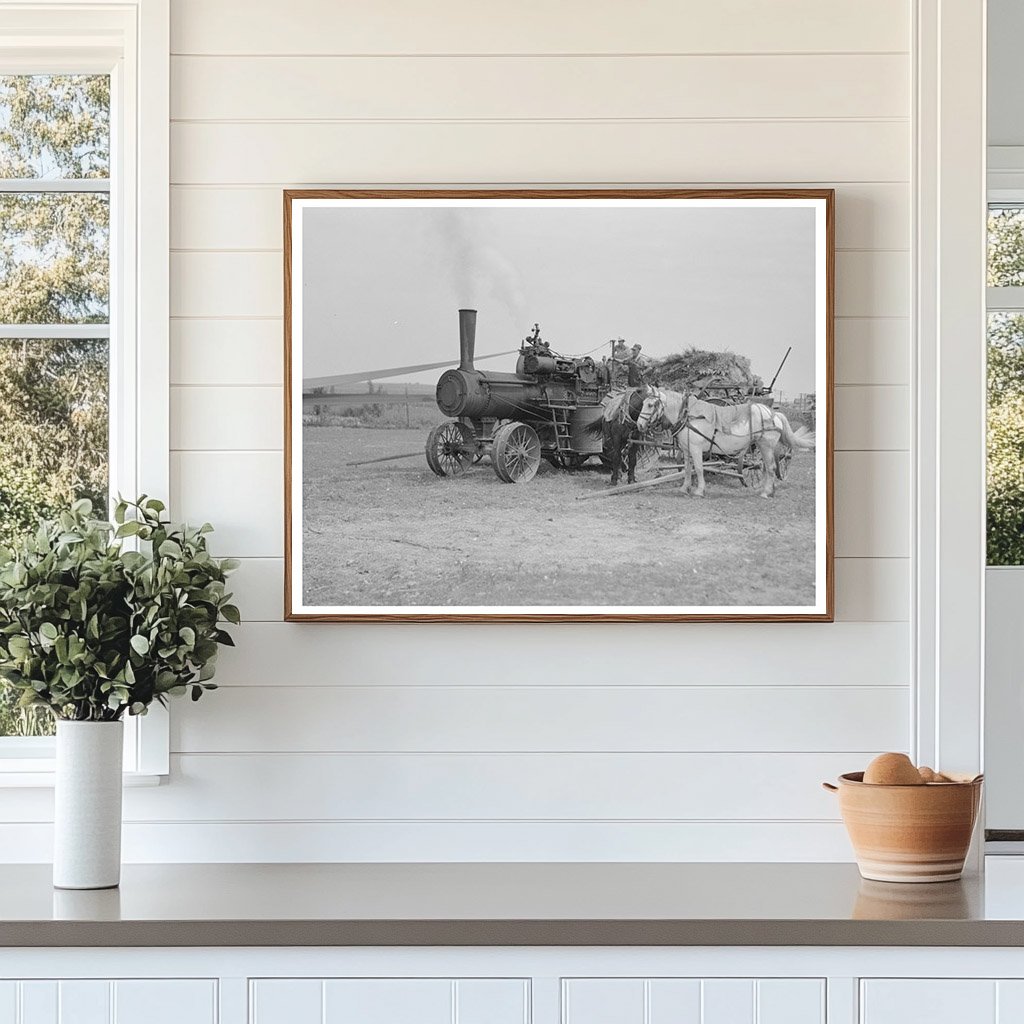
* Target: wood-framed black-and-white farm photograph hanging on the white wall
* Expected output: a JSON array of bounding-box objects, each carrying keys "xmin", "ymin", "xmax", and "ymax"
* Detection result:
[{"xmin": 284, "ymin": 188, "xmax": 835, "ymax": 622}]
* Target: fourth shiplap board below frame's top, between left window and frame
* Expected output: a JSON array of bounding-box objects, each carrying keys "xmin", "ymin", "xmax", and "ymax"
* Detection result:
[{"xmin": 171, "ymin": 385, "xmax": 285, "ymax": 452}]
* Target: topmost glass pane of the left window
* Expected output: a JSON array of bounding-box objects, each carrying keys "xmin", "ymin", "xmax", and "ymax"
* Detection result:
[{"xmin": 0, "ymin": 75, "xmax": 111, "ymax": 180}]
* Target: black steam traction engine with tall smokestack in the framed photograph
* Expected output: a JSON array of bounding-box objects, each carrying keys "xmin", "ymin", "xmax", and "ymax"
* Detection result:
[{"xmin": 427, "ymin": 309, "xmax": 610, "ymax": 483}]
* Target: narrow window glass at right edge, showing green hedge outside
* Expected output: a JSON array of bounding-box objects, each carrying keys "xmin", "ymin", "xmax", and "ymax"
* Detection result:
[{"xmin": 987, "ymin": 203, "xmax": 1024, "ymax": 565}]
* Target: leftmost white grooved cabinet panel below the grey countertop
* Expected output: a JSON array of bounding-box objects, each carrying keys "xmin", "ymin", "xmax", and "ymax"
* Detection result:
[{"xmin": 0, "ymin": 979, "xmax": 217, "ymax": 1024}]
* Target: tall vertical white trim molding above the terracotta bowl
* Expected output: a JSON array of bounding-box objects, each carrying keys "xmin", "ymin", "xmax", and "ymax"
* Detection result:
[{"xmin": 912, "ymin": 0, "xmax": 987, "ymax": 771}]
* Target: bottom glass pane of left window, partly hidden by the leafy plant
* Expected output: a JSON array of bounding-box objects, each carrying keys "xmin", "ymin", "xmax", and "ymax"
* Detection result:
[{"xmin": 0, "ymin": 338, "xmax": 109, "ymax": 736}]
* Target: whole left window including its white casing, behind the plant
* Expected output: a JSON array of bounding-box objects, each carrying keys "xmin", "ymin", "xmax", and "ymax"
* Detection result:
[{"xmin": 0, "ymin": 0, "xmax": 169, "ymax": 784}]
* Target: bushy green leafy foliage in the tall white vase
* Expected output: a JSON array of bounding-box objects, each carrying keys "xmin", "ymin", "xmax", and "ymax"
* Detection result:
[{"xmin": 0, "ymin": 498, "xmax": 241, "ymax": 721}]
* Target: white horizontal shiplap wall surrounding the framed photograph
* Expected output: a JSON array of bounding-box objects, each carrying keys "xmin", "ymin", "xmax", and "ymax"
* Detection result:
[{"xmin": 6, "ymin": 0, "xmax": 911, "ymax": 860}]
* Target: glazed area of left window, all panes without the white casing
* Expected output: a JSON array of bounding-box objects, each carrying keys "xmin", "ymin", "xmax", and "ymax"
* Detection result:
[{"xmin": 0, "ymin": 75, "xmax": 111, "ymax": 736}]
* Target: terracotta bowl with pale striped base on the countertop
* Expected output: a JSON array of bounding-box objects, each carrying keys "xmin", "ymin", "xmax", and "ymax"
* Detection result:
[{"xmin": 822, "ymin": 771, "xmax": 982, "ymax": 882}]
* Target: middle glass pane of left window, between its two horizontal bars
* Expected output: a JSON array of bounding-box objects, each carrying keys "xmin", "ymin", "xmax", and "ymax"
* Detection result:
[{"xmin": 0, "ymin": 193, "xmax": 111, "ymax": 324}]
